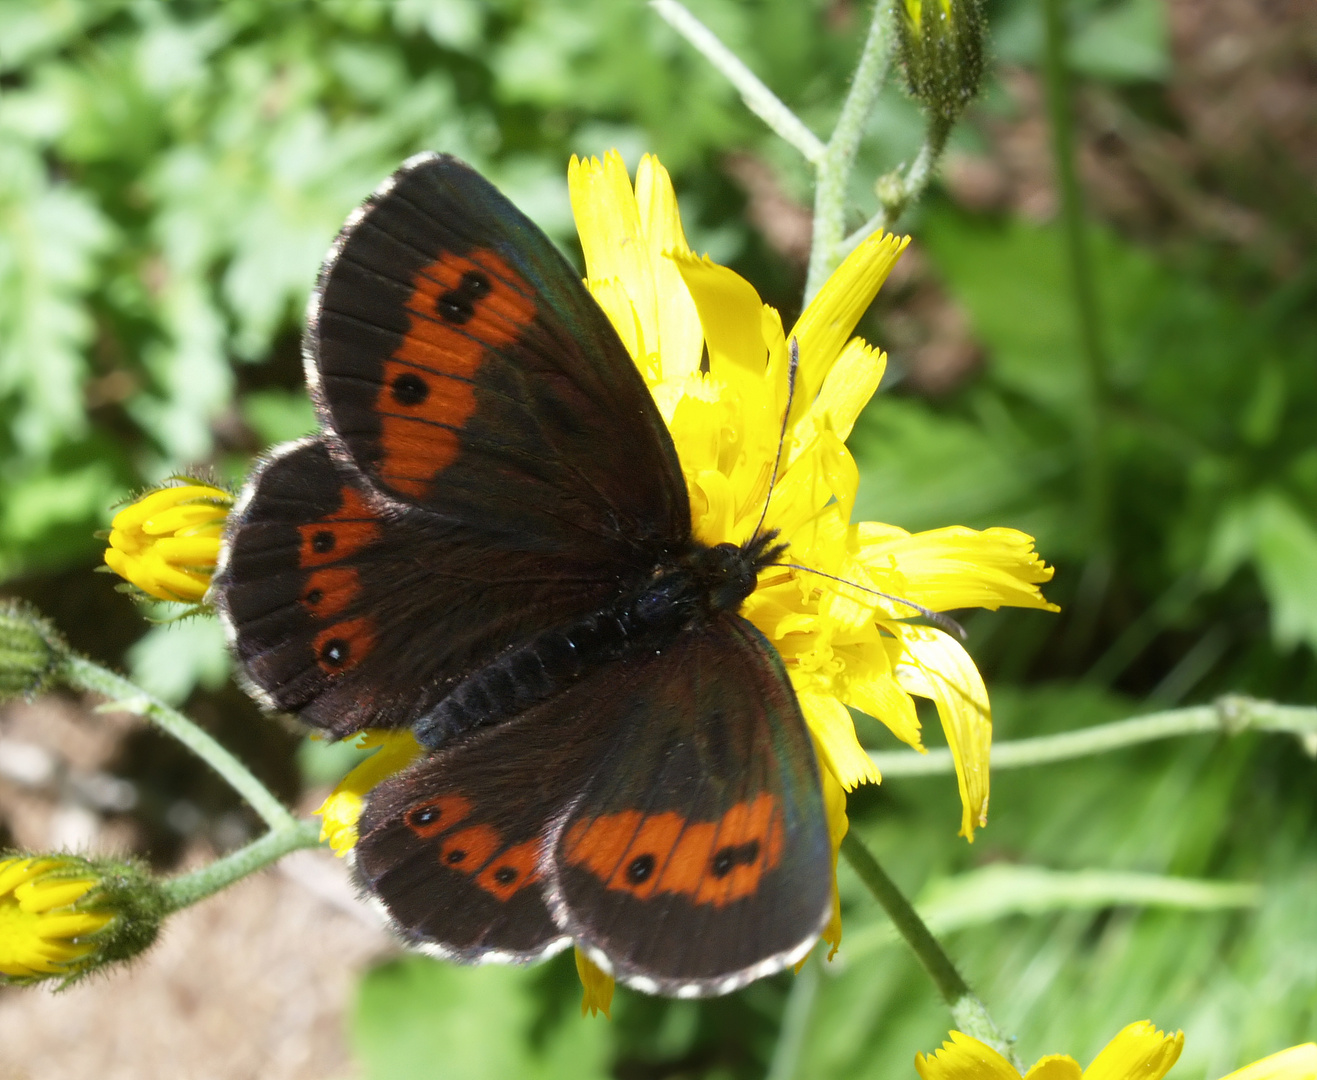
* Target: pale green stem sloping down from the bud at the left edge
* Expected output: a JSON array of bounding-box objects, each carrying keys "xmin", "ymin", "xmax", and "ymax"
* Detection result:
[{"xmin": 61, "ymin": 655, "xmax": 298, "ymax": 831}]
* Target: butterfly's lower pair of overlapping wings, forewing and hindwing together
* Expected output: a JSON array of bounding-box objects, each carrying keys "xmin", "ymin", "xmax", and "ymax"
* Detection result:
[{"xmin": 357, "ymin": 615, "xmax": 831, "ymax": 994}]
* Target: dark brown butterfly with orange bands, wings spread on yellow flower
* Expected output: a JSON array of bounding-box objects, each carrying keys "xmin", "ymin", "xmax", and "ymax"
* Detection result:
[{"xmin": 212, "ymin": 154, "xmax": 831, "ymax": 997}]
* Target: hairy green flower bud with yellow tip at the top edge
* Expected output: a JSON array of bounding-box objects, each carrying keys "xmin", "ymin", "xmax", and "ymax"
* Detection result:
[{"xmin": 896, "ymin": 0, "xmax": 985, "ymax": 124}]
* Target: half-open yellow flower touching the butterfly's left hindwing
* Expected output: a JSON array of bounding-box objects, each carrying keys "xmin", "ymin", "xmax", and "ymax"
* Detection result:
[{"xmin": 105, "ymin": 477, "xmax": 233, "ymax": 605}]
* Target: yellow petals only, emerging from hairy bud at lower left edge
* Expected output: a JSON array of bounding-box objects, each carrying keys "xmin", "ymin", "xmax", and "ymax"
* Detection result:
[{"xmin": 0, "ymin": 856, "xmax": 113, "ymax": 981}]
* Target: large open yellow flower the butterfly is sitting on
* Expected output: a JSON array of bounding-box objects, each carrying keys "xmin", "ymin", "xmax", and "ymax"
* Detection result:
[{"xmin": 568, "ymin": 153, "xmax": 1055, "ymax": 843}]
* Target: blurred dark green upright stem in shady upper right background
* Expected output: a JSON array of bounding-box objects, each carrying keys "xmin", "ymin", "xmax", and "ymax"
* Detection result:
[{"xmin": 1043, "ymin": 0, "xmax": 1109, "ymax": 548}]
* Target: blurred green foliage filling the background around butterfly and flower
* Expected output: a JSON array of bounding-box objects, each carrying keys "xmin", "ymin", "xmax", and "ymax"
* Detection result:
[{"xmin": 0, "ymin": 0, "xmax": 1317, "ymax": 1080}]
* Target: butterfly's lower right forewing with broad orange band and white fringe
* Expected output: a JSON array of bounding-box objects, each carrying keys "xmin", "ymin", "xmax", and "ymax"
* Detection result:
[{"xmin": 553, "ymin": 614, "xmax": 831, "ymax": 996}]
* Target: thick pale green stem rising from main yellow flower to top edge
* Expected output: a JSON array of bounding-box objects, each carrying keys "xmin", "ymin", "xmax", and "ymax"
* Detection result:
[{"xmin": 805, "ymin": 0, "xmax": 892, "ymax": 303}]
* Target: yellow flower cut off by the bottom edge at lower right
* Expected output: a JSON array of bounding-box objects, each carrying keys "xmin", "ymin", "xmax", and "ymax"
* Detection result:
[{"xmin": 914, "ymin": 1021, "xmax": 1317, "ymax": 1080}]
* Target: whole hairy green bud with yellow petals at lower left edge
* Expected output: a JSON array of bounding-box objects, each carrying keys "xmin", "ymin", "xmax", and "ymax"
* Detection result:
[{"xmin": 0, "ymin": 853, "xmax": 167, "ymax": 985}]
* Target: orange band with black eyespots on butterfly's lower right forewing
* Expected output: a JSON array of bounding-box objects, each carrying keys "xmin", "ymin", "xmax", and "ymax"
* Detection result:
[{"xmin": 564, "ymin": 793, "xmax": 784, "ymax": 907}]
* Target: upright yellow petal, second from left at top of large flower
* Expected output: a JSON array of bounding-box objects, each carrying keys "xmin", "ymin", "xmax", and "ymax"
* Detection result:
[{"xmin": 636, "ymin": 154, "xmax": 705, "ymax": 379}]
